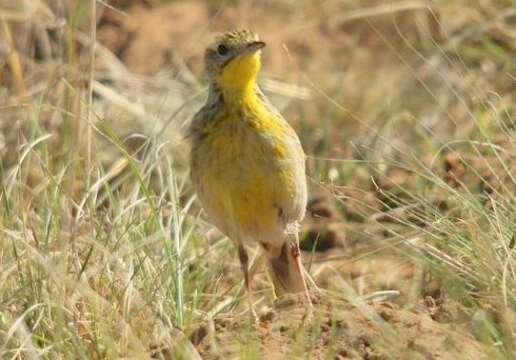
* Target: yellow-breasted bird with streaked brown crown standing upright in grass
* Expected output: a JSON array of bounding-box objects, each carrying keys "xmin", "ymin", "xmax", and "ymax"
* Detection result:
[{"xmin": 187, "ymin": 30, "xmax": 312, "ymax": 319}]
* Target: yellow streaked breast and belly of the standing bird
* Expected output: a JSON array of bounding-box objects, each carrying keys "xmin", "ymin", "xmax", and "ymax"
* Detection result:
[{"xmin": 192, "ymin": 99, "xmax": 305, "ymax": 237}]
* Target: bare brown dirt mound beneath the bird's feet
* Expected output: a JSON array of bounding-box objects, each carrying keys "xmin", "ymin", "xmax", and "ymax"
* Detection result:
[{"xmin": 184, "ymin": 297, "xmax": 485, "ymax": 359}]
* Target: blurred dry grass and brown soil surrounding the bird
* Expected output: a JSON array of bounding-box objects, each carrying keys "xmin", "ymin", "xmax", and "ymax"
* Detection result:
[{"xmin": 0, "ymin": 0, "xmax": 516, "ymax": 358}]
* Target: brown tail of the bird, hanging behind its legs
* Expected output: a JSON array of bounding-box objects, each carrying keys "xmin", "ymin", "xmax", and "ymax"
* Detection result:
[{"xmin": 268, "ymin": 241, "xmax": 306, "ymax": 296}]
